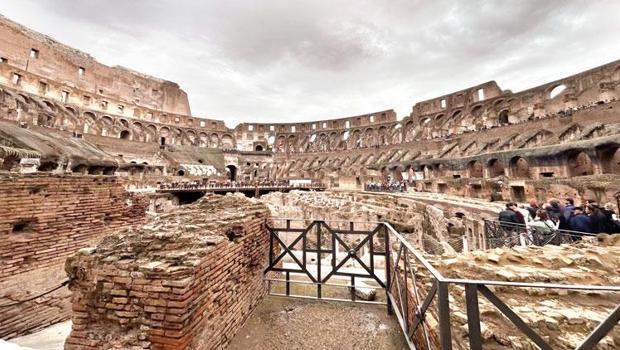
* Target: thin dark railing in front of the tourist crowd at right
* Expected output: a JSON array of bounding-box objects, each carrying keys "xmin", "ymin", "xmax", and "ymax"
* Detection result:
[{"xmin": 484, "ymin": 220, "xmax": 596, "ymax": 249}]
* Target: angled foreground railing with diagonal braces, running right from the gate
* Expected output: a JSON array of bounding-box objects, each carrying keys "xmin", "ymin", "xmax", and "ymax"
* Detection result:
[{"xmin": 382, "ymin": 223, "xmax": 620, "ymax": 350}]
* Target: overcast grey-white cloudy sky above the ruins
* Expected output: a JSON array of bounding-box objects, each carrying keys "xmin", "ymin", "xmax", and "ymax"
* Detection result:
[{"xmin": 0, "ymin": 0, "xmax": 620, "ymax": 127}]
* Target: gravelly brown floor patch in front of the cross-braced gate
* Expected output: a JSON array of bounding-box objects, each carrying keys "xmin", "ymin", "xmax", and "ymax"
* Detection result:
[{"xmin": 229, "ymin": 296, "xmax": 407, "ymax": 350}]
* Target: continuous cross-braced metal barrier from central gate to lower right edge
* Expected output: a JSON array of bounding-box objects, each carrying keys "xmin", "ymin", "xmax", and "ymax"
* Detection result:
[{"xmin": 265, "ymin": 217, "xmax": 620, "ymax": 350}]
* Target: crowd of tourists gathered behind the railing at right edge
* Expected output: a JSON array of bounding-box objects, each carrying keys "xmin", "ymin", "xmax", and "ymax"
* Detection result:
[{"xmin": 498, "ymin": 198, "xmax": 620, "ymax": 234}]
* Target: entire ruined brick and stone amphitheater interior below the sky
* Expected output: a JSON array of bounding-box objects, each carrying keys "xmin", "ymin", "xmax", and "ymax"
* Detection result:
[{"xmin": 0, "ymin": 13, "xmax": 620, "ymax": 350}]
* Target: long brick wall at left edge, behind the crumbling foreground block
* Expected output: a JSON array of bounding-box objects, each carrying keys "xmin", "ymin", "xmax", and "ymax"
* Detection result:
[{"xmin": 0, "ymin": 173, "xmax": 148, "ymax": 339}]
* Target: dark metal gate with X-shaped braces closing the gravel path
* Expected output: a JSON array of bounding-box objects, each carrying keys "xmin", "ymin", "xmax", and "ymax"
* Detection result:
[{"xmin": 265, "ymin": 219, "xmax": 390, "ymax": 301}]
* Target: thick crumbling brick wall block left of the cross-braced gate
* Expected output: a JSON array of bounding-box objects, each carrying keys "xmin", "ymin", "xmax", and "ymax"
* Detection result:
[{"xmin": 65, "ymin": 195, "xmax": 270, "ymax": 350}]
